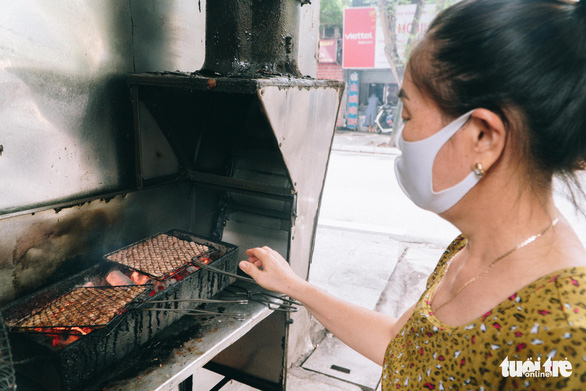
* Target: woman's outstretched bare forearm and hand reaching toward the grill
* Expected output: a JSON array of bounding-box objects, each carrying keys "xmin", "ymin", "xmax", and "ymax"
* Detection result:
[{"xmin": 240, "ymin": 247, "xmax": 413, "ymax": 365}]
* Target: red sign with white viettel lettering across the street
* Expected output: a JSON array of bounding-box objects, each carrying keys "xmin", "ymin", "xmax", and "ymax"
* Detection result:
[{"xmin": 342, "ymin": 8, "xmax": 376, "ymax": 68}]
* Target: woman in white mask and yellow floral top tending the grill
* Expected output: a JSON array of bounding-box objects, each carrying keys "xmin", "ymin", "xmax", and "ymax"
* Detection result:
[{"xmin": 240, "ymin": 0, "xmax": 586, "ymax": 390}]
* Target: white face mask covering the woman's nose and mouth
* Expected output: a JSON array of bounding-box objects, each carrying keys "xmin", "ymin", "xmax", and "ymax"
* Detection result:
[{"xmin": 395, "ymin": 111, "xmax": 480, "ymax": 214}]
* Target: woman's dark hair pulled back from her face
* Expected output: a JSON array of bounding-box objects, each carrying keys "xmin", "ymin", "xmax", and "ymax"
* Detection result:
[{"xmin": 409, "ymin": 0, "xmax": 586, "ymax": 182}]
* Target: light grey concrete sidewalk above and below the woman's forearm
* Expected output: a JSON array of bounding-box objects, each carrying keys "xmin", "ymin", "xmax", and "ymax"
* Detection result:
[{"xmin": 287, "ymin": 226, "xmax": 444, "ymax": 391}]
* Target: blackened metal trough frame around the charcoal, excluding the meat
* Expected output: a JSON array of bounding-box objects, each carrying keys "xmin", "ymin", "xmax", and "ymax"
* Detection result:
[{"xmin": 2, "ymin": 230, "xmax": 238, "ymax": 391}]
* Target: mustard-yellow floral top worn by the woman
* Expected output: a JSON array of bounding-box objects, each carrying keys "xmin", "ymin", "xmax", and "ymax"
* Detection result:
[{"xmin": 382, "ymin": 237, "xmax": 586, "ymax": 391}]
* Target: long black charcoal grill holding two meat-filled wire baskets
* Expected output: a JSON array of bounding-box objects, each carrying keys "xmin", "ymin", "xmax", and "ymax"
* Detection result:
[{"xmin": 4, "ymin": 230, "xmax": 238, "ymax": 391}]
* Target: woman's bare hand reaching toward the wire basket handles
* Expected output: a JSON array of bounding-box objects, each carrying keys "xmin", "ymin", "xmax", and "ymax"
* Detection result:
[{"xmin": 240, "ymin": 246, "xmax": 305, "ymax": 298}]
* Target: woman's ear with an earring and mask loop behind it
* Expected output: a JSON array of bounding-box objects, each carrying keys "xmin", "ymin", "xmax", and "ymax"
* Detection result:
[{"xmin": 468, "ymin": 109, "xmax": 507, "ymax": 171}]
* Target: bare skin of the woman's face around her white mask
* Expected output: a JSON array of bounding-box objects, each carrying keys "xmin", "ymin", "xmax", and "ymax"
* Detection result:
[{"xmin": 399, "ymin": 71, "xmax": 474, "ymax": 192}]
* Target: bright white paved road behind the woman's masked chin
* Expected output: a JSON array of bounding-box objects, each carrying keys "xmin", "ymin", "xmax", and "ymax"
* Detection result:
[{"xmin": 319, "ymin": 151, "xmax": 458, "ymax": 244}]
